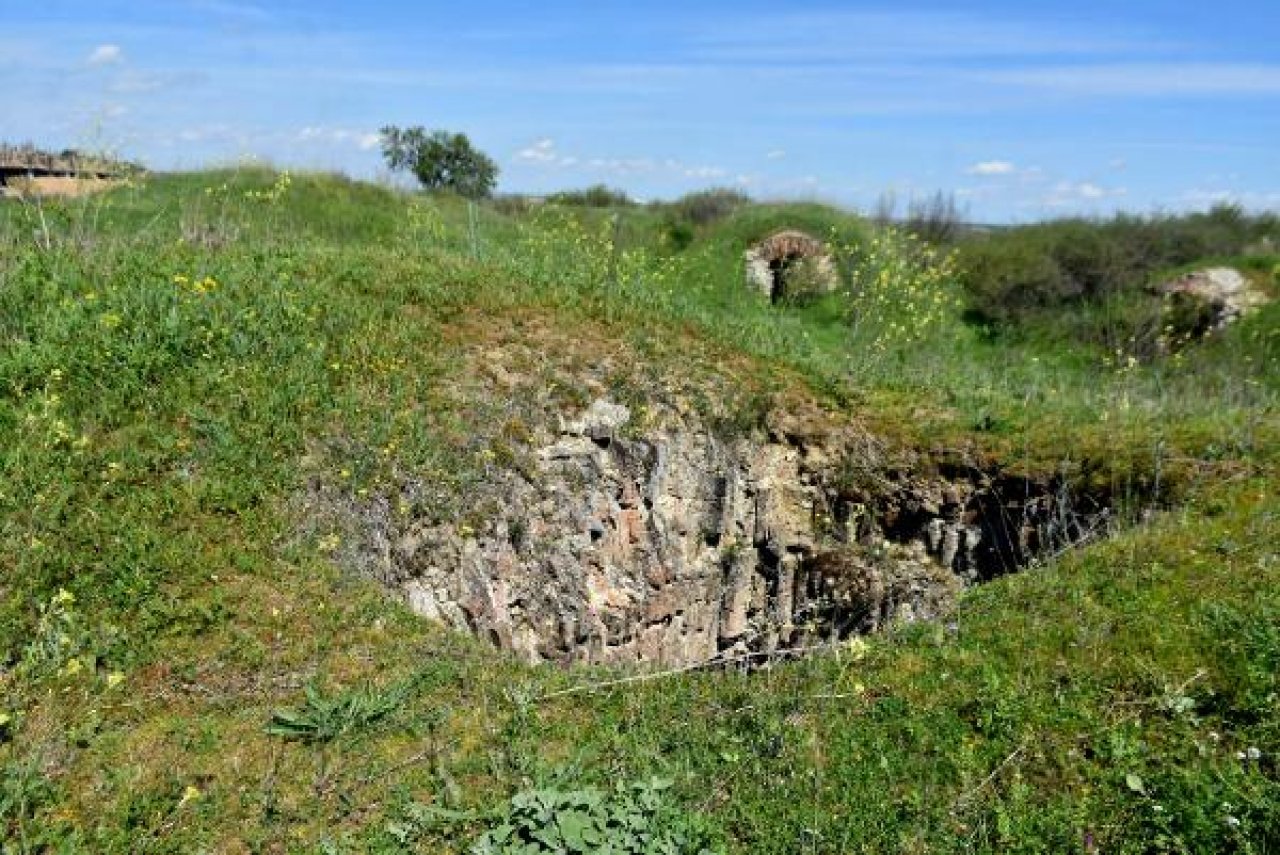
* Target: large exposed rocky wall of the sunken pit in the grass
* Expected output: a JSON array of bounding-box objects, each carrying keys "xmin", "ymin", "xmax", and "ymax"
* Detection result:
[{"xmin": 345, "ymin": 401, "xmax": 1106, "ymax": 666}]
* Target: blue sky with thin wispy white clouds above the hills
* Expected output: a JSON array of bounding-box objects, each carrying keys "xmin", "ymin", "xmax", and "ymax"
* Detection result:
[{"xmin": 0, "ymin": 0, "xmax": 1280, "ymax": 221}]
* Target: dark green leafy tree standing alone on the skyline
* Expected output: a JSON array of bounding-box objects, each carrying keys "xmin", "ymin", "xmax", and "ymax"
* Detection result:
[{"xmin": 381, "ymin": 125, "xmax": 498, "ymax": 198}]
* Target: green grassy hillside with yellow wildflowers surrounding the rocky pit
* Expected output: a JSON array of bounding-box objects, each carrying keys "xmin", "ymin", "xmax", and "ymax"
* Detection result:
[{"xmin": 0, "ymin": 170, "xmax": 1280, "ymax": 854}]
